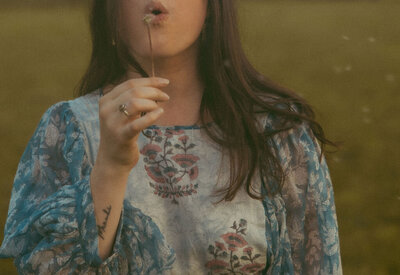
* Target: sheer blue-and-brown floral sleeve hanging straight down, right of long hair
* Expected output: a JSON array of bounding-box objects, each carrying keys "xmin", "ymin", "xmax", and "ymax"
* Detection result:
[{"xmin": 274, "ymin": 122, "xmax": 342, "ymax": 274}]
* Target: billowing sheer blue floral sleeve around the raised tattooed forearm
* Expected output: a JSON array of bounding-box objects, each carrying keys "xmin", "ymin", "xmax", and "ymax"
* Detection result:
[{"xmin": 0, "ymin": 102, "xmax": 174, "ymax": 274}]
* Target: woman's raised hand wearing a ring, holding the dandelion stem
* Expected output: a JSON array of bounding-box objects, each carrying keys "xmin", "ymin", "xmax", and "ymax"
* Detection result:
[{"xmin": 96, "ymin": 77, "xmax": 169, "ymax": 172}]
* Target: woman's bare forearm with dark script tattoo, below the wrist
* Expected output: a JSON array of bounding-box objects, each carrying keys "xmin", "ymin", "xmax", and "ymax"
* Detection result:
[{"xmin": 90, "ymin": 159, "xmax": 129, "ymax": 260}]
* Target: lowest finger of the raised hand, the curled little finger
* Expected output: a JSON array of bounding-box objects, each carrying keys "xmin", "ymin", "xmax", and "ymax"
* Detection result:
[{"xmin": 122, "ymin": 108, "xmax": 164, "ymax": 139}]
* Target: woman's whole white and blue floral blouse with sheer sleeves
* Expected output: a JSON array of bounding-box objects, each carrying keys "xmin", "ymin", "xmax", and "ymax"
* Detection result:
[{"xmin": 0, "ymin": 89, "xmax": 342, "ymax": 274}]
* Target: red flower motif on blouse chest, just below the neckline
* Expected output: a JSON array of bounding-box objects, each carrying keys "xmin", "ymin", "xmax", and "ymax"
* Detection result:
[{"xmin": 140, "ymin": 129, "xmax": 200, "ymax": 204}]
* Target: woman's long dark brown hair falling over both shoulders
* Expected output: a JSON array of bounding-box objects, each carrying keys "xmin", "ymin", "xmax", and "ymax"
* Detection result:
[{"xmin": 77, "ymin": 0, "xmax": 336, "ymax": 202}]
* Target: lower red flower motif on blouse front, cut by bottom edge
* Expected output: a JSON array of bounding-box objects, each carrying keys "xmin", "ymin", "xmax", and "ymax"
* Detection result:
[{"xmin": 205, "ymin": 219, "xmax": 265, "ymax": 274}]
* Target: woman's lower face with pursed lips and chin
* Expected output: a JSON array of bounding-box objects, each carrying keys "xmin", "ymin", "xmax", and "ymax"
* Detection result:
[{"xmin": 119, "ymin": 0, "xmax": 208, "ymax": 59}]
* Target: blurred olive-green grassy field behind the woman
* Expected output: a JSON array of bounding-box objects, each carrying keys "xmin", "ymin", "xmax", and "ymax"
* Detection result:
[{"xmin": 0, "ymin": 0, "xmax": 400, "ymax": 274}]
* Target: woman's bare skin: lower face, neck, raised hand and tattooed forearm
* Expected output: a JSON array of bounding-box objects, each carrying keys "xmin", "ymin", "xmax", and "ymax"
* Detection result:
[{"xmin": 90, "ymin": 0, "xmax": 208, "ymax": 260}]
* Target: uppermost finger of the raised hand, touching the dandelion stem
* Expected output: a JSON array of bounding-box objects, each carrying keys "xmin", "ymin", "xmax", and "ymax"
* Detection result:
[{"xmin": 104, "ymin": 77, "xmax": 169, "ymax": 99}]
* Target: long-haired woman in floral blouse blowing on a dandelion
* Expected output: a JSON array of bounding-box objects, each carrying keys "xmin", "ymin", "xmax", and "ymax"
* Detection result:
[{"xmin": 0, "ymin": 0, "xmax": 342, "ymax": 274}]
